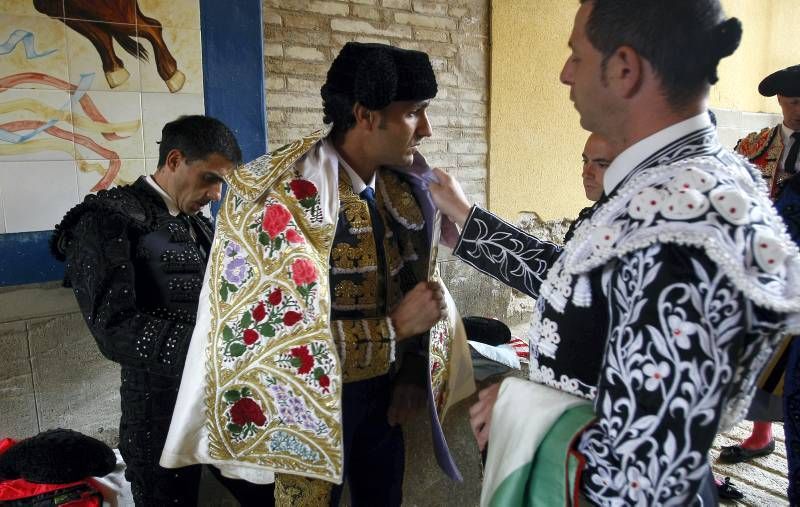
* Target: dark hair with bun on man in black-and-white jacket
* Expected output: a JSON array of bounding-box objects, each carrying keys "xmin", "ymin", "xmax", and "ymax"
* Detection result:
[{"xmin": 580, "ymin": 0, "xmax": 742, "ymax": 108}]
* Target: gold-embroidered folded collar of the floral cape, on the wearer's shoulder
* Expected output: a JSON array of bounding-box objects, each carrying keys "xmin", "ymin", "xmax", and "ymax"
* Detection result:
[{"xmin": 227, "ymin": 130, "xmax": 327, "ymax": 201}]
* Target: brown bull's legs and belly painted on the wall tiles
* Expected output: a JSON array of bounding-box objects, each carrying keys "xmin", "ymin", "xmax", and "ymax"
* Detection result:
[{"xmin": 33, "ymin": 0, "xmax": 186, "ymax": 93}]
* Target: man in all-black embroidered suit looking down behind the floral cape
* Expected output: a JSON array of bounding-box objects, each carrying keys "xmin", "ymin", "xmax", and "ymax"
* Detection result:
[{"xmin": 52, "ymin": 116, "xmax": 269, "ymax": 507}]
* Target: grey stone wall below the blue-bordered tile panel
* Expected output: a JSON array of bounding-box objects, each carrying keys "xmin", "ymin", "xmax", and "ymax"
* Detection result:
[{"xmin": 0, "ymin": 282, "xmax": 119, "ymax": 446}]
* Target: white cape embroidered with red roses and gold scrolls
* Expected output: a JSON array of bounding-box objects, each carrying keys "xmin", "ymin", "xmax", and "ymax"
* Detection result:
[{"xmin": 161, "ymin": 132, "xmax": 474, "ymax": 483}]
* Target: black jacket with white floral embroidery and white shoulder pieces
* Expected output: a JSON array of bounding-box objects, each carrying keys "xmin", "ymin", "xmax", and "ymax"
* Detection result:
[{"xmin": 455, "ymin": 126, "xmax": 800, "ymax": 505}]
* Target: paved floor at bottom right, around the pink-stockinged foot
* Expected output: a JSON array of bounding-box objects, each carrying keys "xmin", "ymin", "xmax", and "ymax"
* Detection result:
[{"xmin": 710, "ymin": 422, "xmax": 789, "ymax": 507}]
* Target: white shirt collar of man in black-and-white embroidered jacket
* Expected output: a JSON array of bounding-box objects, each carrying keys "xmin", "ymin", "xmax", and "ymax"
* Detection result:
[{"xmin": 603, "ymin": 111, "xmax": 711, "ymax": 195}]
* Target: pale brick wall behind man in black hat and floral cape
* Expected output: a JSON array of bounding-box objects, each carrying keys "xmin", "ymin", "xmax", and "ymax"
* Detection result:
[{"xmin": 262, "ymin": 0, "xmax": 489, "ymax": 204}]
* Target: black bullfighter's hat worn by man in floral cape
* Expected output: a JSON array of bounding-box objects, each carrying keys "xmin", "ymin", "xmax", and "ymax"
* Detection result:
[{"xmin": 322, "ymin": 42, "xmax": 438, "ymax": 111}]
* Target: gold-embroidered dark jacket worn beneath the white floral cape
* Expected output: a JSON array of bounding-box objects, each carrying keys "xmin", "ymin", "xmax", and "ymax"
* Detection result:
[{"xmin": 330, "ymin": 169, "xmax": 428, "ymax": 382}]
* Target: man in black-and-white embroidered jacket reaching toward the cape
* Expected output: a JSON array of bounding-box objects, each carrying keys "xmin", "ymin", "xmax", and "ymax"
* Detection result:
[{"xmin": 431, "ymin": 0, "xmax": 800, "ymax": 505}]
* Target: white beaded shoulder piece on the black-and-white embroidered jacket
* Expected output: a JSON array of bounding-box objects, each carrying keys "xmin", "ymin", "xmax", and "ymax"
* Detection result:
[{"xmin": 556, "ymin": 152, "xmax": 800, "ymax": 313}]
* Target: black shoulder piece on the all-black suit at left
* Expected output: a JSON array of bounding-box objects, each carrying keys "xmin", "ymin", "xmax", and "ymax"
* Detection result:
[{"xmin": 50, "ymin": 185, "xmax": 150, "ymax": 262}]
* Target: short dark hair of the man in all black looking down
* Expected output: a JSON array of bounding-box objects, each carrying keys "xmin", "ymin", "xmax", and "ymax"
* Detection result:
[{"xmin": 158, "ymin": 114, "xmax": 242, "ymax": 167}]
